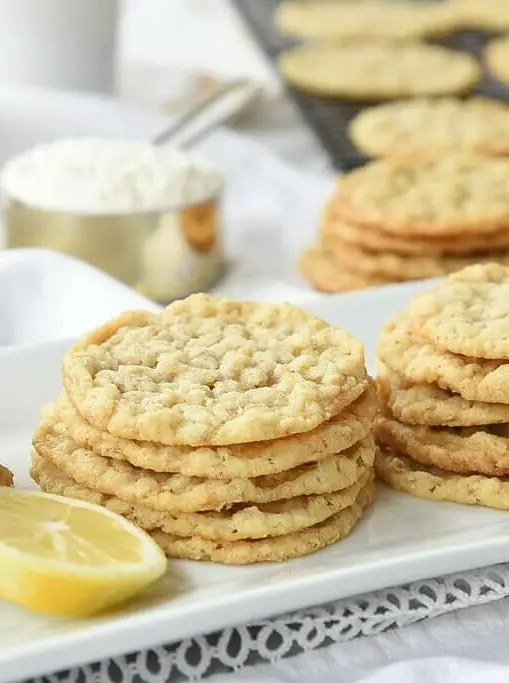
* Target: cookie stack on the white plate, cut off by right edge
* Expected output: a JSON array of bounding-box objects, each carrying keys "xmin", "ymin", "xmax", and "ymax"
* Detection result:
[{"xmin": 374, "ymin": 264, "xmax": 509, "ymax": 509}]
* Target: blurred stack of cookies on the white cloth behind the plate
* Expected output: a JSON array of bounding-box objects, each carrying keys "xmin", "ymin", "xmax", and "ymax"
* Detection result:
[{"xmin": 300, "ymin": 152, "xmax": 509, "ymax": 292}]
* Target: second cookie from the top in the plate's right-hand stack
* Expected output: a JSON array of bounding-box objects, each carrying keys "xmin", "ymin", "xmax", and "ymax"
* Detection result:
[{"xmin": 377, "ymin": 311, "xmax": 509, "ymax": 404}]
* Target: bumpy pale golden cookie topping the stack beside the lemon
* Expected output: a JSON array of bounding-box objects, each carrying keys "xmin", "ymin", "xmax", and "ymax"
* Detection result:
[{"xmin": 63, "ymin": 294, "xmax": 368, "ymax": 446}]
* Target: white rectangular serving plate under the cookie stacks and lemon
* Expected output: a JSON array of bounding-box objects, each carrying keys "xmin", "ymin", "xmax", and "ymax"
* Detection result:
[{"xmin": 0, "ymin": 276, "xmax": 509, "ymax": 683}]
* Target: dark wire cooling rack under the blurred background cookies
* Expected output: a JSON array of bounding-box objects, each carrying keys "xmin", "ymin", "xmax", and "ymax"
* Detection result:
[{"xmin": 233, "ymin": 0, "xmax": 509, "ymax": 171}]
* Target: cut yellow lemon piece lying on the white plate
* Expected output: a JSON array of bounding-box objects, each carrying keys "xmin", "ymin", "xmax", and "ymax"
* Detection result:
[{"xmin": 0, "ymin": 487, "xmax": 166, "ymax": 617}]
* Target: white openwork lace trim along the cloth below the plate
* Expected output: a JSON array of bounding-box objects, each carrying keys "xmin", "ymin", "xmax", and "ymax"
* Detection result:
[{"xmin": 27, "ymin": 563, "xmax": 509, "ymax": 683}]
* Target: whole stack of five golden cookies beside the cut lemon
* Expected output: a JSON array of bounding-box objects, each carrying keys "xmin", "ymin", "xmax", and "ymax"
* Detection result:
[{"xmin": 31, "ymin": 294, "xmax": 377, "ymax": 564}]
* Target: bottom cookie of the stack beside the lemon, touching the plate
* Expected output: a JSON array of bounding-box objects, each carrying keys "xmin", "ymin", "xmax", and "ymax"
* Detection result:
[{"xmin": 152, "ymin": 483, "xmax": 374, "ymax": 564}]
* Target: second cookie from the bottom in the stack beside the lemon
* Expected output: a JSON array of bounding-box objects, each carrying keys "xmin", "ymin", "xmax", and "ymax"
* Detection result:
[{"xmin": 30, "ymin": 453, "xmax": 373, "ymax": 541}]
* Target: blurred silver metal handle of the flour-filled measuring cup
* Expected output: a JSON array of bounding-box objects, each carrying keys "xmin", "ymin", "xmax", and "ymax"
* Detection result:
[{"xmin": 152, "ymin": 79, "xmax": 261, "ymax": 148}]
